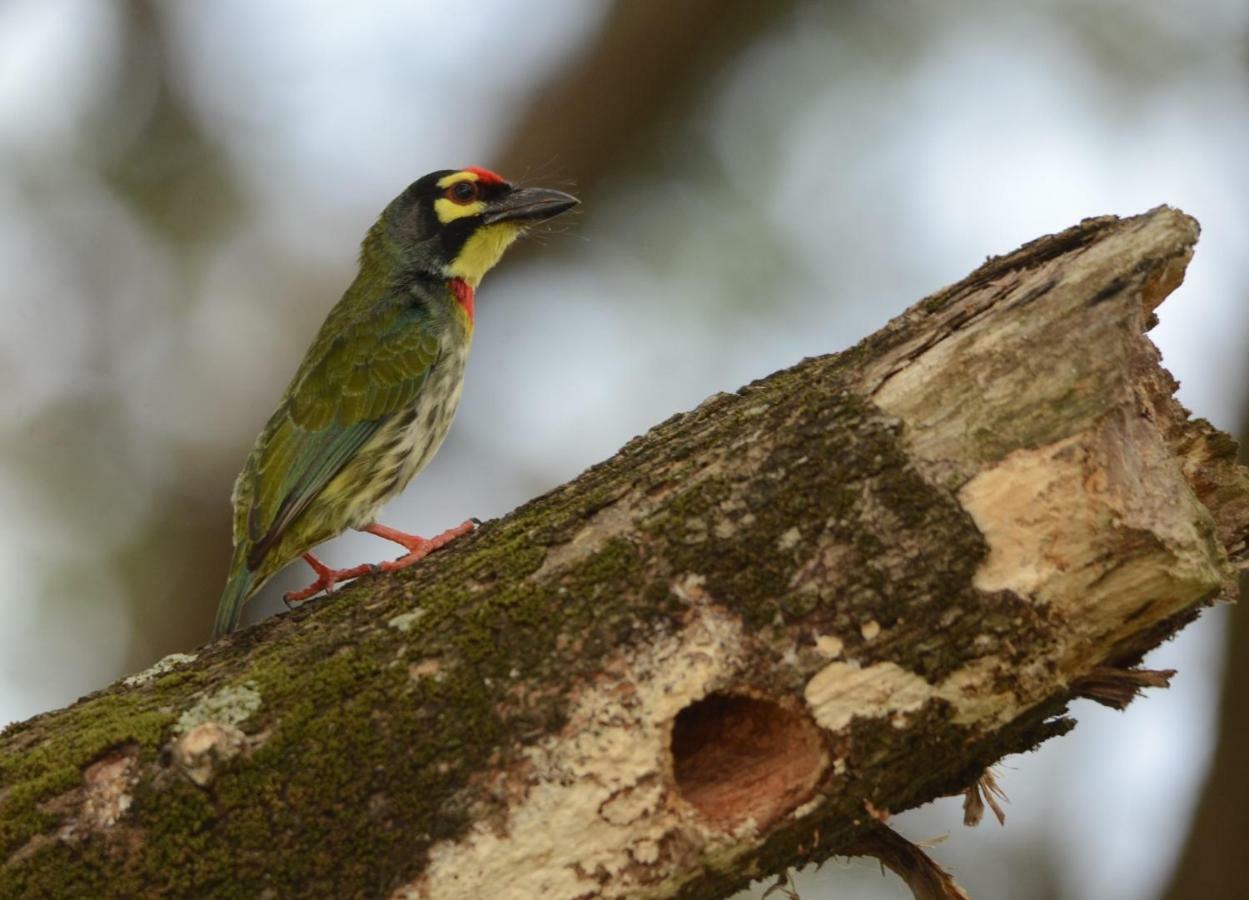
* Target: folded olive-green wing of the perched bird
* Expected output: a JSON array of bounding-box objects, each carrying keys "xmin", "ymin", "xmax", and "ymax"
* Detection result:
[{"xmin": 235, "ymin": 298, "xmax": 438, "ymax": 571}]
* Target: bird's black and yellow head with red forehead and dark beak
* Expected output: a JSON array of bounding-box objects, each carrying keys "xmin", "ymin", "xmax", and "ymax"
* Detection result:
[{"xmin": 378, "ymin": 166, "xmax": 578, "ymax": 287}]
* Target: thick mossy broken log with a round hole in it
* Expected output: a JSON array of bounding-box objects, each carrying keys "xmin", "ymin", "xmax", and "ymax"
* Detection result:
[{"xmin": 0, "ymin": 207, "xmax": 1249, "ymax": 900}]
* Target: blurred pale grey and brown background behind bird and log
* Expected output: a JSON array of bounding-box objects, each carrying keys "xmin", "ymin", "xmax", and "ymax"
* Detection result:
[{"xmin": 0, "ymin": 0, "xmax": 1249, "ymax": 900}]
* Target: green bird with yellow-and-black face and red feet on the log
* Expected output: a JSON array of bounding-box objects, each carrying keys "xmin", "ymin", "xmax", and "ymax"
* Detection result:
[{"xmin": 212, "ymin": 166, "xmax": 580, "ymax": 638}]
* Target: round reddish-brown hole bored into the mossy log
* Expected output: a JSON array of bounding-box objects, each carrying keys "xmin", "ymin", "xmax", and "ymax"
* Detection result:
[{"xmin": 672, "ymin": 694, "xmax": 828, "ymax": 829}]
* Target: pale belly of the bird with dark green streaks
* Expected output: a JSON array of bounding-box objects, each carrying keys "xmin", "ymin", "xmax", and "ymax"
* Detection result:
[{"xmin": 326, "ymin": 346, "xmax": 468, "ymax": 528}]
